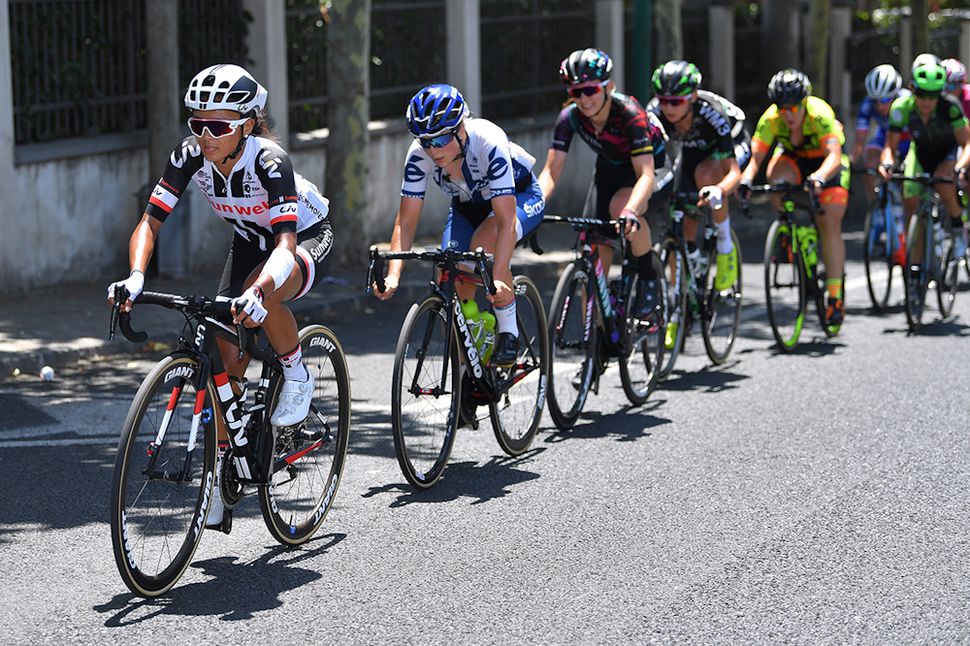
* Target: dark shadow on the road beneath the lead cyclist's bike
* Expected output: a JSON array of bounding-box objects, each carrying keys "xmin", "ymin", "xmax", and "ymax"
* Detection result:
[{"xmin": 94, "ymin": 534, "xmax": 347, "ymax": 628}]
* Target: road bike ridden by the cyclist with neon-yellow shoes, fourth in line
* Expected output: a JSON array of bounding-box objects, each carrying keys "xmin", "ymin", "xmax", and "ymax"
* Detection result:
[{"xmin": 660, "ymin": 191, "xmax": 743, "ymax": 379}]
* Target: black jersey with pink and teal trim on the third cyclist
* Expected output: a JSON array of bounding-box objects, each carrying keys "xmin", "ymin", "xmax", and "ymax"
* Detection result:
[{"xmin": 552, "ymin": 92, "xmax": 666, "ymax": 168}]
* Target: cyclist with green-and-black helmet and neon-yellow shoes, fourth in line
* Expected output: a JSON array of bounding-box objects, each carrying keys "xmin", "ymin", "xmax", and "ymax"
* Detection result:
[{"xmin": 647, "ymin": 60, "xmax": 751, "ymax": 349}]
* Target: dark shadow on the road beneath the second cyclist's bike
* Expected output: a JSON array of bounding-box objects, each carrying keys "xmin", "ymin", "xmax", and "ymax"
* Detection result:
[{"xmin": 363, "ymin": 448, "xmax": 545, "ymax": 508}]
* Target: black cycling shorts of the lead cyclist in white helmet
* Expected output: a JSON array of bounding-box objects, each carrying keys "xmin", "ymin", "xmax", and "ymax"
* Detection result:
[{"xmin": 218, "ymin": 220, "xmax": 333, "ymax": 301}]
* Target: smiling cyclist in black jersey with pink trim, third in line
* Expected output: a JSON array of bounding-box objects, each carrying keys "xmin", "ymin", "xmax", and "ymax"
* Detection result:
[{"xmin": 539, "ymin": 48, "xmax": 669, "ymax": 320}]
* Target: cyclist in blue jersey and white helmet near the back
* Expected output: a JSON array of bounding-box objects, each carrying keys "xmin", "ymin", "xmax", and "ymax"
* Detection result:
[{"xmin": 852, "ymin": 64, "xmax": 909, "ymax": 202}]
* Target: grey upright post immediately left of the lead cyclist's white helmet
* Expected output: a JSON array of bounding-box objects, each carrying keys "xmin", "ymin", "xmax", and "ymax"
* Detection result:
[{"xmin": 146, "ymin": 0, "xmax": 192, "ymax": 278}]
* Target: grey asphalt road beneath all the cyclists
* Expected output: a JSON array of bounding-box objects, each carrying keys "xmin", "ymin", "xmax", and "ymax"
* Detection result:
[{"xmin": 0, "ymin": 234, "xmax": 970, "ymax": 644}]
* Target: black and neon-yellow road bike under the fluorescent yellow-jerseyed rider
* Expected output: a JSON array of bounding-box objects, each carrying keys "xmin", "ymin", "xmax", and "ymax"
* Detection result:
[{"xmin": 741, "ymin": 182, "xmax": 845, "ymax": 352}]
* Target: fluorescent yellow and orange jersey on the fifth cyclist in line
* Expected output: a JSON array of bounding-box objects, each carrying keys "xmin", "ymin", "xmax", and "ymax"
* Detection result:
[{"xmin": 751, "ymin": 96, "xmax": 845, "ymax": 157}]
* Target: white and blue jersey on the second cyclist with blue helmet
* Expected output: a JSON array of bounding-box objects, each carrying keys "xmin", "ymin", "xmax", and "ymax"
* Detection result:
[{"xmin": 401, "ymin": 119, "xmax": 536, "ymax": 203}]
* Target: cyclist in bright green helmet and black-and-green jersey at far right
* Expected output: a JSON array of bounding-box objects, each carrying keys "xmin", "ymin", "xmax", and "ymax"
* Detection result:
[{"xmin": 879, "ymin": 62, "xmax": 970, "ymax": 287}]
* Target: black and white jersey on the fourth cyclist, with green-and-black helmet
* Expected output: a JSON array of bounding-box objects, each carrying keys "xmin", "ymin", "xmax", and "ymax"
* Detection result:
[{"xmin": 647, "ymin": 90, "xmax": 746, "ymax": 159}]
